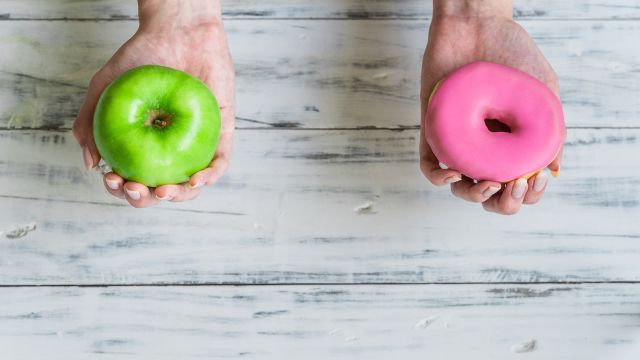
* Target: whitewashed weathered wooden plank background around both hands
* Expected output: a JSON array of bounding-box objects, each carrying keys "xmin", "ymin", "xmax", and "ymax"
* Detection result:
[{"xmin": 0, "ymin": 0, "xmax": 640, "ymax": 360}]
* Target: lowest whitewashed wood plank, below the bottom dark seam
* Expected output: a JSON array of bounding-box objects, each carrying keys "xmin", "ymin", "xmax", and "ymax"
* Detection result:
[{"xmin": 0, "ymin": 284, "xmax": 640, "ymax": 360}]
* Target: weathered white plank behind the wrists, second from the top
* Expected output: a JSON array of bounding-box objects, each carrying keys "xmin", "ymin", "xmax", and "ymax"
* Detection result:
[{"xmin": 0, "ymin": 20, "xmax": 640, "ymax": 128}]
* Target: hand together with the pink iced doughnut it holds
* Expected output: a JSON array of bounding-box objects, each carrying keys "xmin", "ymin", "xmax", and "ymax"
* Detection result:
[{"xmin": 419, "ymin": 0, "xmax": 564, "ymax": 215}]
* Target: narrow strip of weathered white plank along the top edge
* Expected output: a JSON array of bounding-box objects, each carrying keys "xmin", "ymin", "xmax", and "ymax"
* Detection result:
[{"xmin": 0, "ymin": 0, "xmax": 640, "ymax": 20}]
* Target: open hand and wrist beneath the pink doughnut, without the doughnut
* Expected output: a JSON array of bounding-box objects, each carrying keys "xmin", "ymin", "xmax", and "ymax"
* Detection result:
[{"xmin": 420, "ymin": 0, "xmax": 562, "ymax": 215}]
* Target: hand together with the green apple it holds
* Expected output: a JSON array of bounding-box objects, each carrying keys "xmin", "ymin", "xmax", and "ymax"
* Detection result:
[{"xmin": 73, "ymin": 0, "xmax": 235, "ymax": 207}]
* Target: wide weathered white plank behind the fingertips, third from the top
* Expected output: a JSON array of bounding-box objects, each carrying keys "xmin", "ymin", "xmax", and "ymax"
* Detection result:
[{"xmin": 0, "ymin": 129, "xmax": 640, "ymax": 284}]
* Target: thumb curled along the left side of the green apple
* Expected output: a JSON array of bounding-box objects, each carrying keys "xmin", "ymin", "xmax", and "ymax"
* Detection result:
[{"xmin": 72, "ymin": 69, "xmax": 110, "ymax": 170}]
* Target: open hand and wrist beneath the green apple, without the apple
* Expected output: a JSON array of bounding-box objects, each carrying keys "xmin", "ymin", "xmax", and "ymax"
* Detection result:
[{"xmin": 73, "ymin": 0, "xmax": 235, "ymax": 208}]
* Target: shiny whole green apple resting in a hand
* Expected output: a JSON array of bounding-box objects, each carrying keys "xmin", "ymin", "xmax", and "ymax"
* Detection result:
[{"xmin": 93, "ymin": 65, "xmax": 220, "ymax": 186}]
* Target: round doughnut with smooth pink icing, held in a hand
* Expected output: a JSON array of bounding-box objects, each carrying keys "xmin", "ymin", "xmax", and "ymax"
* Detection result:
[{"xmin": 424, "ymin": 61, "xmax": 565, "ymax": 182}]
